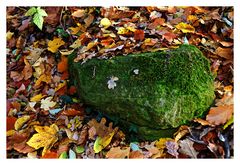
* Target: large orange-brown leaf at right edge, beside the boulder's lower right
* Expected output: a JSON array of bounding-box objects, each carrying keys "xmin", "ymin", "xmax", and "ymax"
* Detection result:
[{"xmin": 206, "ymin": 105, "xmax": 233, "ymax": 125}]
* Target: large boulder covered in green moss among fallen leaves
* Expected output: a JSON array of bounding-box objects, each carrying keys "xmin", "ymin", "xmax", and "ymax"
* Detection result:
[{"xmin": 69, "ymin": 45, "xmax": 215, "ymax": 140}]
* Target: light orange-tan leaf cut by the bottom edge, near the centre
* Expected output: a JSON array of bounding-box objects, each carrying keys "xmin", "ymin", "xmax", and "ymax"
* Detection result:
[{"xmin": 106, "ymin": 147, "xmax": 130, "ymax": 159}]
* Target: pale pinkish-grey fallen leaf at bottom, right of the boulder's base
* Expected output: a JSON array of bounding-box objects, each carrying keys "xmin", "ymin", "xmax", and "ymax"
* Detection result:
[{"xmin": 179, "ymin": 139, "xmax": 198, "ymax": 159}]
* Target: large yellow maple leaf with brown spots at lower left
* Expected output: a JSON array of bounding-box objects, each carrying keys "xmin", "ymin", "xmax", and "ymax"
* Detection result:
[{"xmin": 27, "ymin": 124, "xmax": 58, "ymax": 155}]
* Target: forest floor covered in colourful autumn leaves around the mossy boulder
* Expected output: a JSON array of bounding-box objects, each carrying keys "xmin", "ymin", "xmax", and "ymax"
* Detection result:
[{"xmin": 6, "ymin": 7, "xmax": 234, "ymax": 159}]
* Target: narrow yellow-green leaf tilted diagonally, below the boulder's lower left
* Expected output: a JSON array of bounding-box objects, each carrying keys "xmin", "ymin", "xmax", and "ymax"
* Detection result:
[{"xmin": 94, "ymin": 132, "xmax": 114, "ymax": 153}]
